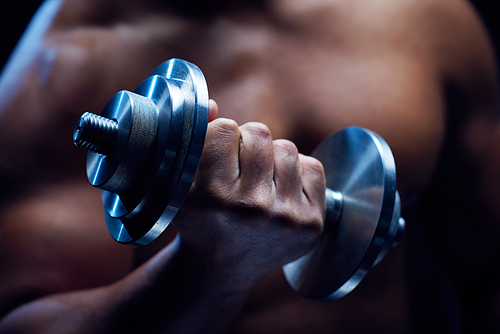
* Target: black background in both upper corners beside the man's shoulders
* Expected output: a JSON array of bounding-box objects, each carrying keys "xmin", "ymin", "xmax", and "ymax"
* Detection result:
[{"xmin": 0, "ymin": 0, "xmax": 500, "ymax": 73}]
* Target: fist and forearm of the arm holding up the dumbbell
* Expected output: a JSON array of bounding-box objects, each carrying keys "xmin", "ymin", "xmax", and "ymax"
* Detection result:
[{"xmin": 0, "ymin": 119, "xmax": 324, "ymax": 333}]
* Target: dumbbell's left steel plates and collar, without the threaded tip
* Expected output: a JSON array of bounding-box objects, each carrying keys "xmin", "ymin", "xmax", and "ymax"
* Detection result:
[{"xmin": 74, "ymin": 59, "xmax": 208, "ymax": 246}]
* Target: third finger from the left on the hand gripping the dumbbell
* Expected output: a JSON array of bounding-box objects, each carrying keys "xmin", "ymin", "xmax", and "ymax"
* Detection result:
[{"xmin": 273, "ymin": 139, "xmax": 302, "ymax": 199}]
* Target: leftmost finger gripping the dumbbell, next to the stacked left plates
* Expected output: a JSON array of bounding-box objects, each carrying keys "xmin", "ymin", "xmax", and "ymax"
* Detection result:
[{"xmin": 196, "ymin": 118, "xmax": 240, "ymax": 184}]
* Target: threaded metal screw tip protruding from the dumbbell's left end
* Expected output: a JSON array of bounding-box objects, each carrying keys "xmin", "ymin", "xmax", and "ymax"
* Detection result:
[{"xmin": 73, "ymin": 112, "xmax": 118, "ymax": 155}]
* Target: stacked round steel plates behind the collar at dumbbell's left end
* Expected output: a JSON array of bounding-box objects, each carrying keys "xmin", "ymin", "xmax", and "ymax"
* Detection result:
[{"xmin": 103, "ymin": 59, "xmax": 208, "ymax": 246}]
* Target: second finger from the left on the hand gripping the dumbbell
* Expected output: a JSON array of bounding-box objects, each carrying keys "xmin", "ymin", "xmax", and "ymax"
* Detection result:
[{"xmin": 240, "ymin": 122, "xmax": 274, "ymax": 189}]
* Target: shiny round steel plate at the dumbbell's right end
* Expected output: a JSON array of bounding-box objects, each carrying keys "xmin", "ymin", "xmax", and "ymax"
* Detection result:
[{"xmin": 283, "ymin": 127, "xmax": 399, "ymax": 300}]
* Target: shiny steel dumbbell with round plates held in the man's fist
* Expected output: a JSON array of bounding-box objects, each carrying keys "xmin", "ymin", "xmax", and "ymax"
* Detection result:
[{"xmin": 73, "ymin": 59, "xmax": 405, "ymax": 300}]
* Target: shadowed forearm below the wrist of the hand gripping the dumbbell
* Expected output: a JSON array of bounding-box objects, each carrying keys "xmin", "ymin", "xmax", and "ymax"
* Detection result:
[{"xmin": 0, "ymin": 236, "xmax": 254, "ymax": 333}]
